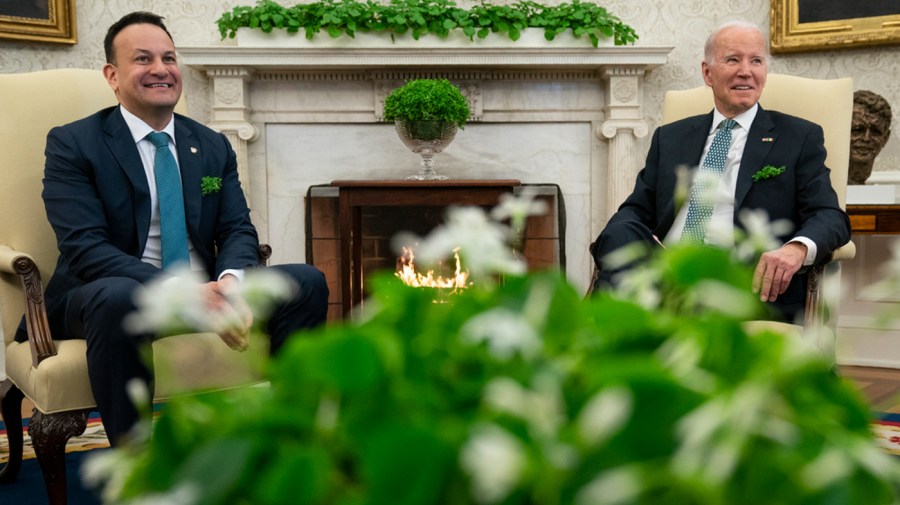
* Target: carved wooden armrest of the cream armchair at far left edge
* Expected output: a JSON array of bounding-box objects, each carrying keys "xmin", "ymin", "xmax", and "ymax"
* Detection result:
[{"xmin": 0, "ymin": 246, "xmax": 56, "ymax": 366}]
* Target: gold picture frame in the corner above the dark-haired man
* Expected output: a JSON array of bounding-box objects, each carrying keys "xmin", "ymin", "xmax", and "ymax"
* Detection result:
[{"xmin": 0, "ymin": 0, "xmax": 78, "ymax": 44}]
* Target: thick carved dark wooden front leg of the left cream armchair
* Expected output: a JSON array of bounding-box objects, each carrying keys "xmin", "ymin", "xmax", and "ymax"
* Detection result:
[{"xmin": 28, "ymin": 409, "xmax": 90, "ymax": 505}]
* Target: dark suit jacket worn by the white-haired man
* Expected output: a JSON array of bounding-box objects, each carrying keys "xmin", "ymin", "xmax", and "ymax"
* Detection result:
[{"xmin": 592, "ymin": 107, "xmax": 850, "ymax": 314}]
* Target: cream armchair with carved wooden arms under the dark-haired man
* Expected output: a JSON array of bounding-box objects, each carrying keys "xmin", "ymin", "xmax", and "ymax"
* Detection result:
[{"xmin": 0, "ymin": 69, "xmax": 269, "ymax": 504}]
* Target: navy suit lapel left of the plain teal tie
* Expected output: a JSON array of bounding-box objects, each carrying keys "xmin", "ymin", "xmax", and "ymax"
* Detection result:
[{"xmin": 103, "ymin": 107, "xmax": 151, "ymax": 251}]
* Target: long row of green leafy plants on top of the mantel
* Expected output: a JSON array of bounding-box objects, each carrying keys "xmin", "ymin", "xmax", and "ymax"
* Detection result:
[{"xmin": 216, "ymin": 0, "xmax": 638, "ymax": 47}]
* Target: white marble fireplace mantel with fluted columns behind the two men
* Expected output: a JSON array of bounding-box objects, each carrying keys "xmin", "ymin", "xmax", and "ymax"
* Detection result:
[{"xmin": 179, "ymin": 45, "xmax": 671, "ymax": 294}]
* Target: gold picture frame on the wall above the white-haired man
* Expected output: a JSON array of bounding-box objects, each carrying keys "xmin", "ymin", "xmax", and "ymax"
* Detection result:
[{"xmin": 770, "ymin": 0, "xmax": 900, "ymax": 53}]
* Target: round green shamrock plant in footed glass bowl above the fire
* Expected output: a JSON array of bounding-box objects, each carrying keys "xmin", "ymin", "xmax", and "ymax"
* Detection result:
[{"xmin": 384, "ymin": 79, "xmax": 469, "ymax": 180}]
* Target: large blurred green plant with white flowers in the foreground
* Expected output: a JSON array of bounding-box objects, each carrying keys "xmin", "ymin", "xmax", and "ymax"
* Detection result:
[{"xmin": 91, "ymin": 193, "xmax": 900, "ymax": 505}]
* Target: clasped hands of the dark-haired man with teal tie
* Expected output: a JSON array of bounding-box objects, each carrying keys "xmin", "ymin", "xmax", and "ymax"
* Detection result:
[{"xmin": 203, "ymin": 275, "xmax": 253, "ymax": 351}]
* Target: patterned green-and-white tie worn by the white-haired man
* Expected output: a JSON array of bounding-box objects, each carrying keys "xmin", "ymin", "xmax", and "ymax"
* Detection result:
[{"xmin": 681, "ymin": 119, "xmax": 737, "ymax": 244}]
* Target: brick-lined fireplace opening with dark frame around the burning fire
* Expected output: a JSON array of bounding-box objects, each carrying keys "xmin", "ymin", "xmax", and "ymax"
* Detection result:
[{"xmin": 306, "ymin": 181, "xmax": 565, "ymax": 321}]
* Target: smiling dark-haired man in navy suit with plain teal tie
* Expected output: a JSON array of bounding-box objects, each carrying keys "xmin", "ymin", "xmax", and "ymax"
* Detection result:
[{"xmin": 27, "ymin": 12, "xmax": 328, "ymax": 444}]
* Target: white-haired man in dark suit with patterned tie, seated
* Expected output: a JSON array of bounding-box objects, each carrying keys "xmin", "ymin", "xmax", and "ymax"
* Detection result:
[{"xmin": 591, "ymin": 22, "xmax": 850, "ymax": 321}]
